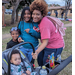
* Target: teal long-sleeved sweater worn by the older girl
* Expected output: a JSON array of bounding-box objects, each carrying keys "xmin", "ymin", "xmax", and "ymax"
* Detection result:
[{"xmin": 18, "ymin": 21, "xmax": 40, "ymax": 49}]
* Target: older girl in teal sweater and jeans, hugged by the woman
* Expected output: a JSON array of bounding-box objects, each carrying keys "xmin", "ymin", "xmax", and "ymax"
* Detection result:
[{"xmin": 18, "ymin": 7, "xmax": 40, "ymax": 62}]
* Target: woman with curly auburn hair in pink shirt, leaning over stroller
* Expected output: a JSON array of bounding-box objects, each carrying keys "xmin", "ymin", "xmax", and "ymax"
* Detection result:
[{"xmin": 30, "ymin": 0, "xmax": 64, "ymax": 66}]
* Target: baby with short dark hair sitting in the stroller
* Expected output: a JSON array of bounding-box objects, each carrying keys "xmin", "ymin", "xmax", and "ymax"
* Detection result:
[{"xmin": 10, "ymin": 49, "xmax": 31, "ymax": 75}]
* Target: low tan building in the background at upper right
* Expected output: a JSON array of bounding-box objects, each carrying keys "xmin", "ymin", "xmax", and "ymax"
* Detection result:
[{"xmin": 48, "ymin": 6, "xmax": 72, "ymax": 16}]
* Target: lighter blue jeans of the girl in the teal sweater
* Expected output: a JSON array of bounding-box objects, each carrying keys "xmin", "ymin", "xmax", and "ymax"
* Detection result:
[{"xmin": 20, "ymin": 46, "xmax": 38, "ymax": 62}]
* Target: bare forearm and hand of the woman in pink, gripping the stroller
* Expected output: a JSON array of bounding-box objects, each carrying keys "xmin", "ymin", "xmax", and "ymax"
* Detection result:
[{"xmin": 32, "ymin": 39, "xmax": 48, "ymax": 59}]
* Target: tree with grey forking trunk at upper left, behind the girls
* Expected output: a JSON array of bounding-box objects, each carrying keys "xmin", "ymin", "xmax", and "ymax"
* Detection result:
[{"xmin": 7, "ymin": 0, "xmax": 33, "ymax": 24}]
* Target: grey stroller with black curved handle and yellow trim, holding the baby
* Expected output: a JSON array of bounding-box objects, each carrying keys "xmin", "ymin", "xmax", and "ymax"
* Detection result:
[{"xmin": 2, "ymin": 42, "xmax": 72, "ymax": 75}]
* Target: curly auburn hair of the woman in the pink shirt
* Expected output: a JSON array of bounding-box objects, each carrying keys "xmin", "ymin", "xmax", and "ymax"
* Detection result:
[{"xmin": 30, "ymin": 0, "xmax": 48, "ymax": 17}]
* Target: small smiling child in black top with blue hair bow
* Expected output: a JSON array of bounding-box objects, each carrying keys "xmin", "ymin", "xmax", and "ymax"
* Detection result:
[{"xmin": 6, "ymin": 27, "xmax": 20, "ymax": 49}]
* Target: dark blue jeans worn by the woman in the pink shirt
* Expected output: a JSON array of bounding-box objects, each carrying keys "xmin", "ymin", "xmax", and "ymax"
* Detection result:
[{"xmin": 37, "ymin": 47, "xmax": 63, "ymax": 66}]
